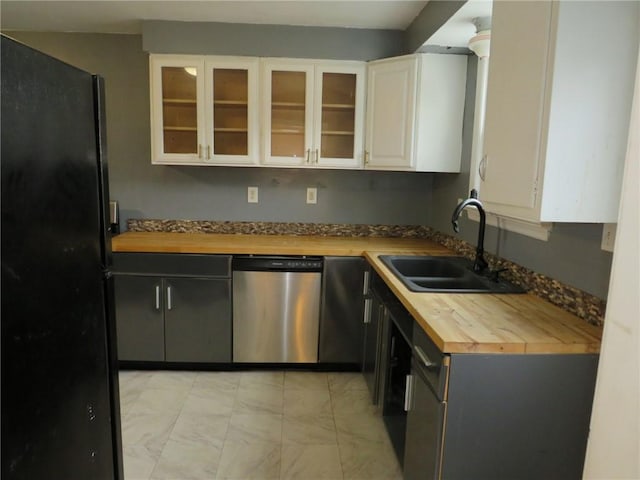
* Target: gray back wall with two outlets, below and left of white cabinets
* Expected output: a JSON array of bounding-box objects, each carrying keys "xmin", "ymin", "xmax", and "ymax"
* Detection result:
[{"xmin": 9, "ymin": 32, "xmax": 432, "ymax": 230}]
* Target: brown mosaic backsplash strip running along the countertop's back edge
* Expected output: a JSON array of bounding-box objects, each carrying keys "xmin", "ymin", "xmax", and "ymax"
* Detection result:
[{"xmin": 127, "ymin": 219, "xmax": 606, "ymax": 325}]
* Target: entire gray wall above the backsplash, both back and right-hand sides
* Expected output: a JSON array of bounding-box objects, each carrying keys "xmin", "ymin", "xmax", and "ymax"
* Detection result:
[{"xmin": 7, "ymin": 32, "xmax": 611, "ymax": 298}]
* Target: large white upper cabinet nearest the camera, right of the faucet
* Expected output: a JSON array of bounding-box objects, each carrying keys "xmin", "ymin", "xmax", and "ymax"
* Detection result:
[{"xmin": 479, "ymin": 1, "xmax": 639, "ymax": 223}]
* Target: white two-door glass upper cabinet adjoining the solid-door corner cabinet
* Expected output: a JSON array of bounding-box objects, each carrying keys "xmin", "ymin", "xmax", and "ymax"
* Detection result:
[{"xmin": 263, "ymin": 59, "xmax": 365, "ymax": 168}]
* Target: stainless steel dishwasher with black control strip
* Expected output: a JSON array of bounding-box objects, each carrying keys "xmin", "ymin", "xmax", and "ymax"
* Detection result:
[{"xmin": 232, "ymin": 256, "xmax": 323, "ymax": 363}]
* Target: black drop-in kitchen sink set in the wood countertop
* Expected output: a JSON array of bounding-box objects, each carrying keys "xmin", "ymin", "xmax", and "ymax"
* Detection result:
[{"xmin": 380, "ymin": 255, "xmax": 524, "ymax": 293}]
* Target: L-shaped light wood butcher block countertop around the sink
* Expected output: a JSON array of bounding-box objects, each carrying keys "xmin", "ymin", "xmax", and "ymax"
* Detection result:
[{"xmin": 112, "ymin": 232, "xmax": 602, "ymax": 353}]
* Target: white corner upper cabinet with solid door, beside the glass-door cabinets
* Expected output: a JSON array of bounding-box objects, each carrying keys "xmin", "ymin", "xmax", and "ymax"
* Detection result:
[{"xmin": 365, "ymin": 54, "xmax": 467, "ymax": 172}]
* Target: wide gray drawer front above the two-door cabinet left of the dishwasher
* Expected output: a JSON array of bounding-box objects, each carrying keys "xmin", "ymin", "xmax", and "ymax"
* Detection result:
[{"xmin": 113, "ymin": 253, "xmax": 231, "ymax": 278}]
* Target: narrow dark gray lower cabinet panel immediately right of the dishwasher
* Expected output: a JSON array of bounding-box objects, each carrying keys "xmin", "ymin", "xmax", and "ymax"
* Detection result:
[{"xmin": 318, "ymin": 257, "xmax": 367, "ymax": 366}]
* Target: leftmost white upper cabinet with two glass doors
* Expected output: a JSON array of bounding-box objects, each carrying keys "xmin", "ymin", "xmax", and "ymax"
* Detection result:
[{"xmin": 150, "ymin": 55, "xmax": 259, "ymax": 165}]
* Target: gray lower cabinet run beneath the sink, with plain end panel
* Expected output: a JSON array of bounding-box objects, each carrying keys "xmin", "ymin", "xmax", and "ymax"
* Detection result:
[{"xmin": 363, "ymin": 273, "xmax": 598, "ymax": 480}]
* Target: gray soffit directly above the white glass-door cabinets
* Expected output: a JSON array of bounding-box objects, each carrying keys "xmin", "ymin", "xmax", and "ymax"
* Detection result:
[{"xmin": 142, "ymin": 20, "xmax": 406, "ymax": 61}]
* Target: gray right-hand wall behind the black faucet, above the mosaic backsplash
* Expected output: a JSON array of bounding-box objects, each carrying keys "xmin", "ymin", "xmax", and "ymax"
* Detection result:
[{"xmin": 429, "ymin": 55, "xmax": 612, "ymax": 298}]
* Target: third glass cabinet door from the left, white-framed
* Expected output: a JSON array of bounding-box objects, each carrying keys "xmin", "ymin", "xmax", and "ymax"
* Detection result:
[{"xmin": 265, "ymin": 64, "xmax": 313, "ymax": 165}]
